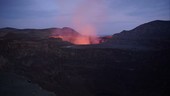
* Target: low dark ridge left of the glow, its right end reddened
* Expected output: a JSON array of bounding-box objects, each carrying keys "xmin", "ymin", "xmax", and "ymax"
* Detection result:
[{"xmin": 0, "ymin": 27, "xmax": 80, "ymax": 40}]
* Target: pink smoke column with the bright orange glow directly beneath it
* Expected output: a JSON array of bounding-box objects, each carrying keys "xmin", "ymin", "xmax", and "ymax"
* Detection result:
[{"xmin": 72, "ymin": 0, "xmax": 104, "ymax": 44}]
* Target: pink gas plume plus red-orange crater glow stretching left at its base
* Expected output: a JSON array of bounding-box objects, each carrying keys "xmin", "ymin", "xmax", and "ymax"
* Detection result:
[{"xmin": 51, "ymin": 0, "xmax": 104, "ymax": 44}]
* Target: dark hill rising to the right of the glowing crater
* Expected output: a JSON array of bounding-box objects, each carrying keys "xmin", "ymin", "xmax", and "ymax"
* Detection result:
[{"xmin": 98, "ymin": 20, "xmax": 170, "ymax": 50}]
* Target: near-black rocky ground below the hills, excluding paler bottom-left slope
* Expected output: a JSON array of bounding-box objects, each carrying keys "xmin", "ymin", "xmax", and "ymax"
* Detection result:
[{"xmin": 0, "ymin": 39, "xmax": 170, "ymax": 96}]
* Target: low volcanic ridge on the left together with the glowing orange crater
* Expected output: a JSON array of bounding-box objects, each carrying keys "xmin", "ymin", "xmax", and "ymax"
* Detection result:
[{"xmin": 0, "ymin": 27, "xmax": 110, "ymax": 45}]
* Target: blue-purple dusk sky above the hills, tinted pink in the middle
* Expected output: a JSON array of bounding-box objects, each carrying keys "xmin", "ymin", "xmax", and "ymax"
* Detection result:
[{"xmin": 0, "ymin": 0, "xmax": 170, "ymax": 35}]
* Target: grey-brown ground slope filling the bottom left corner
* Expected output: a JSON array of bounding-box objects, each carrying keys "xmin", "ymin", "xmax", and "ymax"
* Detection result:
[{"xmin": 0, "ymin": 73, "xmax": 56, "ymax": 96}]
